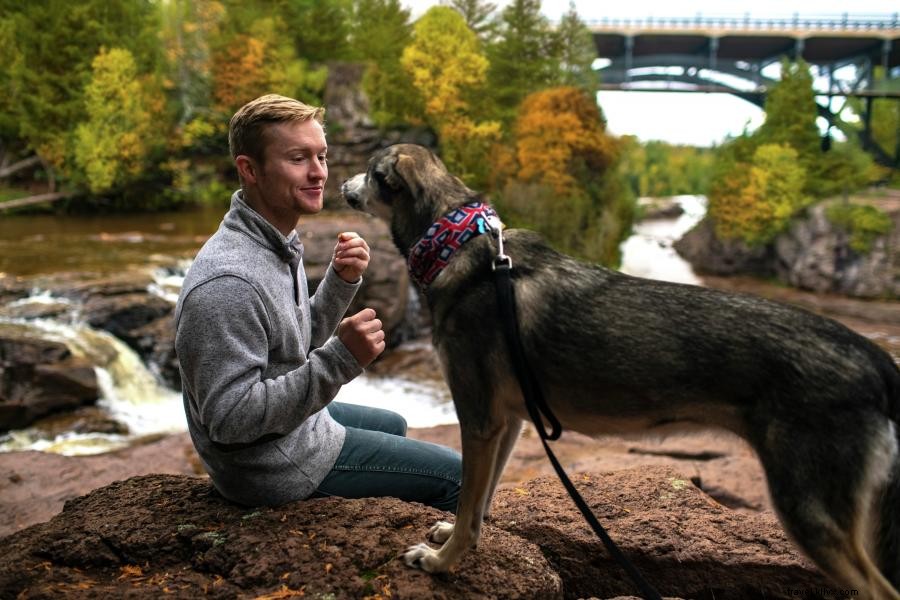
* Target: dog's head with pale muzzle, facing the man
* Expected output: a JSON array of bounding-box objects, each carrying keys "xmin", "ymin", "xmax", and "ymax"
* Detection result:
[{"xmin": 341, "ymin": 144, "xmax": 475, "ymax": 252}]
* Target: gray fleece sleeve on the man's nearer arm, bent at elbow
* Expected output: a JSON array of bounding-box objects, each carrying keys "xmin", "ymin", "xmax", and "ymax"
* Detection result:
[{"xmin": 175, "ymin": 275, "xmax": 362, "ymax": 444}]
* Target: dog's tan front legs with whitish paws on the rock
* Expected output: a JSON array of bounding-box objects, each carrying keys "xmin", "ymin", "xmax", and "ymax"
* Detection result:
[{"xmin": 403, "ymin": 423, "xmax": 509, "ymax": 573}]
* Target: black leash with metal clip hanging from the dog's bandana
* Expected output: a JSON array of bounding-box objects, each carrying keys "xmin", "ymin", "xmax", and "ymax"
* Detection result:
[{"xmin": 493, "ymin": 252, "xmax": 662, "ymax": 600}]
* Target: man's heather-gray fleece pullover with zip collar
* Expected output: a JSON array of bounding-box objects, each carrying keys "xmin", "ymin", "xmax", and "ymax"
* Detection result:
[{"xmin": 175, "ymin": 191, "xmax": 362, "ymax": 506}]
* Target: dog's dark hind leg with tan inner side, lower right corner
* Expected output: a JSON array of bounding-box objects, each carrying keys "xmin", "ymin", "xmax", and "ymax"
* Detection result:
[{"xmin": 760, "ymin": 417, "xmax": 900, "ymax": 600}]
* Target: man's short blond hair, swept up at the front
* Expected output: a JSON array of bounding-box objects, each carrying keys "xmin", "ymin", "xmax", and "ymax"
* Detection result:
[{"xmin": 228, "ymin": 94, "xmax": 325, "ymax": 163}]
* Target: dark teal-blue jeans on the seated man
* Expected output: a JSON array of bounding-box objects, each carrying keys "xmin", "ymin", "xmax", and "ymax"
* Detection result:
[{"xmin": 312, "ymin": 402, "xmax": 462, "ymax": 513}]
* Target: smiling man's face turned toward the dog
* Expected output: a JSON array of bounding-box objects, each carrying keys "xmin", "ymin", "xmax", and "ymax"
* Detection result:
[{"xmin": 256, "ymin": 119, "xmax": 328, "ymax": 216}]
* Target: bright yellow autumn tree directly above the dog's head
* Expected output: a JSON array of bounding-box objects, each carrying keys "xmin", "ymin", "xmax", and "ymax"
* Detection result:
[{"xmin": 401, "ymin": 6, "xmax": 500, "ymax": 187}]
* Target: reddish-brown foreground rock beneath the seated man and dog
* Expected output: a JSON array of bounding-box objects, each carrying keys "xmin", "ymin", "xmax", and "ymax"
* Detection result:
[{"xmin": 0, "ymin": 426, "xmax": 828, "ymax": 599}]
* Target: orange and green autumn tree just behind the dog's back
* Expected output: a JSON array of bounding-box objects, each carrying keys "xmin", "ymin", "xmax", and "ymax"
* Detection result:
[{"xmin": 498, "ymin": 87, "xmax": 634, "ymax": 265}]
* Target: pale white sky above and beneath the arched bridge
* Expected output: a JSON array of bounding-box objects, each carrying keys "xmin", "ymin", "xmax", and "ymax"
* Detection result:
[{"xmin": 402, "ymin": 0, "xmax": 900, "ymax": 146}]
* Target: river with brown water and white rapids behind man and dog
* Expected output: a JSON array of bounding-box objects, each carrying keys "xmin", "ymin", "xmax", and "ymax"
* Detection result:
[{"xmin": 0, "ymin": 196, "xmax": 900, "ymax": 455}]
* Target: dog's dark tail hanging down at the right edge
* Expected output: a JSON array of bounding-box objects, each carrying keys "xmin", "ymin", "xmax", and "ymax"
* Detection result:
[{"xmin": 878, "ymin": 361, "xmax": 900, "ymax": 591}]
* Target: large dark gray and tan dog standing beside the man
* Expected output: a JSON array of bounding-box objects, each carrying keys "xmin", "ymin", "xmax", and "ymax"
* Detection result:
[{"xmin": 341, "ymin": 144, "xmax": 900, "ymax": 600}]
